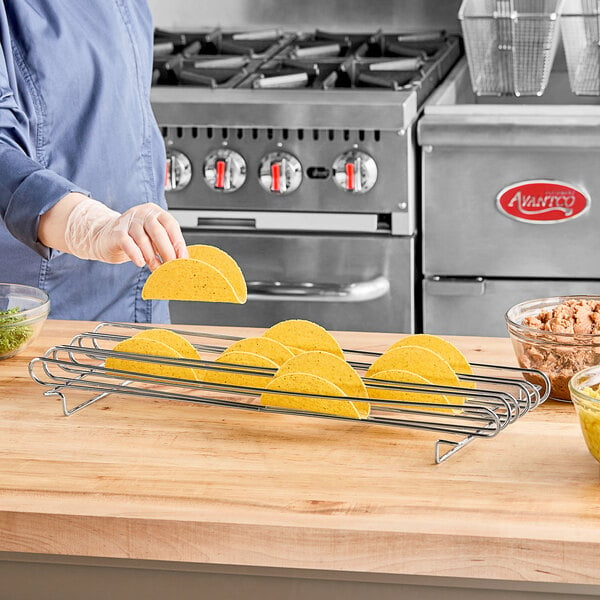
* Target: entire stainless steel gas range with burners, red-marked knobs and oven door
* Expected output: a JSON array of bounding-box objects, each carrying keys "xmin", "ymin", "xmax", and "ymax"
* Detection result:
[{"xmin": 152, "ymin": 29, "xmax": 461, "ymax": 332}]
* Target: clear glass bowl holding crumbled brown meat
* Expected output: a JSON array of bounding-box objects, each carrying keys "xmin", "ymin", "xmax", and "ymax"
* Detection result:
[{"xmin": 505, "ymin": 296, "xmax": 600, "ymax": 402}]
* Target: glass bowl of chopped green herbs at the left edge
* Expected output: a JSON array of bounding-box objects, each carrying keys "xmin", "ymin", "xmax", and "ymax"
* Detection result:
[{"xmin": 0, "ymin": 283, "xmax": 50, "ymax": 359}]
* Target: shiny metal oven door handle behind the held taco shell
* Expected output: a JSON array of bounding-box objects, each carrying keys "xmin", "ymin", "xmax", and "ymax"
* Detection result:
[{"xmin": 246, "ymin": 276, "xmax": 390, "ymax": 302}]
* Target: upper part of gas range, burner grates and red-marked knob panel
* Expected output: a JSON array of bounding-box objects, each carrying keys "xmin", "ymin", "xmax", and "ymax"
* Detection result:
[{"xmin": 152, "ymin": 29, "xmax": 461, "ymax": 235}]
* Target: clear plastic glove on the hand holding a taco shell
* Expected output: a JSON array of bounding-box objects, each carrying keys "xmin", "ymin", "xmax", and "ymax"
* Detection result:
[{"xmin": 64, "ymin": 197, "xmax": 188, "ymax": 271}]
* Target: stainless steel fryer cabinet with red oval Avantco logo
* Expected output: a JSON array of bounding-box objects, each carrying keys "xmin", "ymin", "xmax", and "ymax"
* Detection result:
[{"xmin": 419, "ymin": 62, "xmax": 600, "ymax": 336}]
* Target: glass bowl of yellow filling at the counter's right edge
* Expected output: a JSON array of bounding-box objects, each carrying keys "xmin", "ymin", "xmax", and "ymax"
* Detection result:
[{"xmin": 569, "ymin": 366, "xmax": 600, "ymax": 462}]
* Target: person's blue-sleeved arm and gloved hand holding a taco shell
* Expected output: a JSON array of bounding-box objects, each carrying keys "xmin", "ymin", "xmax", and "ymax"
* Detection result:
[{"xmin": 0, "ymin": 11, "xmax": 187, "ymax": 269}]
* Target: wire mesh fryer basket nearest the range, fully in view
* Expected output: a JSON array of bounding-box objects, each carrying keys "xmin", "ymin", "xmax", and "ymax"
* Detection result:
[{"xmin": 458, "ymin": 0, "xmax": 563, "ymax": 96}]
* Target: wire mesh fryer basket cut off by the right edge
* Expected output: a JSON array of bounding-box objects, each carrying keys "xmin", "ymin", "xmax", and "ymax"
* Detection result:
[{"xmin": 560, "ymin": 0, "xmax": 600, "ymax": 96}]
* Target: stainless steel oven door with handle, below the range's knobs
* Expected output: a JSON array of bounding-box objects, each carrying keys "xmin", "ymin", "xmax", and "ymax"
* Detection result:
[{"xmin": 170, "ymin": 229, "xmax": 415, "ymax": 333}]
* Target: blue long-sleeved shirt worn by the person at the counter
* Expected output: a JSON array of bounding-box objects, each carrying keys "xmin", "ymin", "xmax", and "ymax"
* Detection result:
[{"xmin": 0, "ymin": 0, "xmax": 168, "ymax": 322}]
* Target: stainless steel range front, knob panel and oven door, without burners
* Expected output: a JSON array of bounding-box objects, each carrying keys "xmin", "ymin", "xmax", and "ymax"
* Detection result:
[{"xmin": 159, "ymin": 110, "xmax": 418, "ymax": 332}]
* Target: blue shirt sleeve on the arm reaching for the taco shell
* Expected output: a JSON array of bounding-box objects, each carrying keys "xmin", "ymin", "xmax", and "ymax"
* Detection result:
[{"xmin": 0, "ymin": 2, "xmax": 89, "ymax": 258}]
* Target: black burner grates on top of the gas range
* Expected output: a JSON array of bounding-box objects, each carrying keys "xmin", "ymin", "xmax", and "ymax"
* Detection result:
[{"xmin": 154, "ymin": 30, "xmax": 456, "ymax": 95}]
